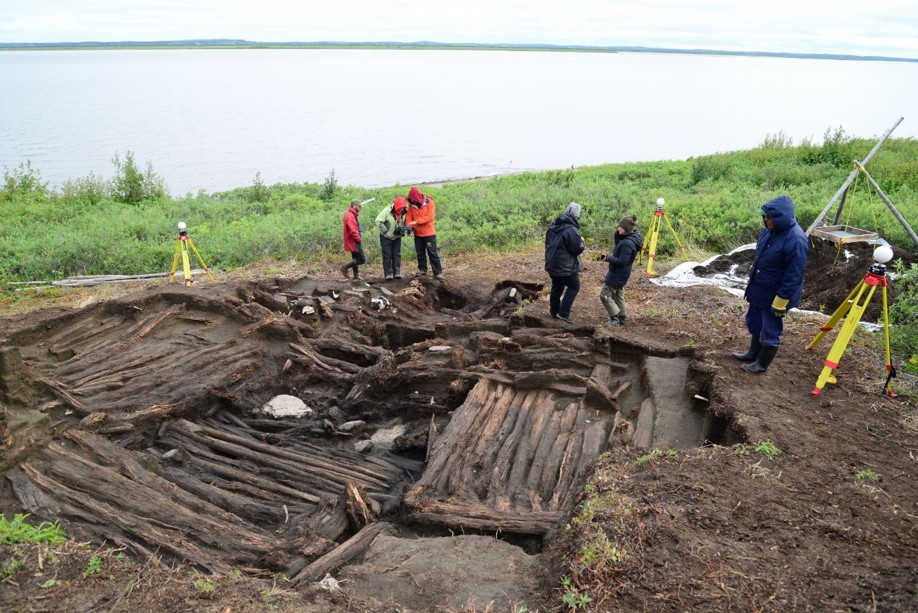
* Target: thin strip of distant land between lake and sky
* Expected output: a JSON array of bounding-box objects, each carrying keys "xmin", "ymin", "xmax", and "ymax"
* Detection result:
[{"xmin": 0, "ymin": 38, "xmax": 918, "ymax": 62}]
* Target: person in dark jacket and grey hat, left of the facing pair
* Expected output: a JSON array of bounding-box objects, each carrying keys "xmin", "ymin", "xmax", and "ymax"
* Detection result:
[{"xmin": 545, "ymin": 202, "xmax": 585, "ymax": 324}]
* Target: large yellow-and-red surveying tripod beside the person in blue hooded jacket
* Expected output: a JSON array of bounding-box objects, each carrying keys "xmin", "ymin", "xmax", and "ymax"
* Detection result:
[{"xmin": 806, "ymin": 250, "xmax": 896, "ymax": 398}]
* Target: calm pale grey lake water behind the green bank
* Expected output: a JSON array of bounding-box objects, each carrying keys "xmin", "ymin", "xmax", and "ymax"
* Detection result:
[{"xmin": 0, "ymin": 49, "xmax": 918, "ymax": 196}]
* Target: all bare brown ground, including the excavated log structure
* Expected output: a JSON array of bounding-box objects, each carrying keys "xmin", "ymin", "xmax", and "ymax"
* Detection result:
[{"xmin": 0, "ymin": 241, "xmax": 918, "ymax": 611}]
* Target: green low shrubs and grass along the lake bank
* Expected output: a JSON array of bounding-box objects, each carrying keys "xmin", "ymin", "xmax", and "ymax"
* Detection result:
[{"xmin": 0, "ymin": 129, "xmax": 918, "ymax": 368}]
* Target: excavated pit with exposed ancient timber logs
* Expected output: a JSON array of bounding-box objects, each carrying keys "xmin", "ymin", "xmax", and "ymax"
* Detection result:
[{"xmin": 0, "ymin": 272, "xmax": 743, "ymax": 582}]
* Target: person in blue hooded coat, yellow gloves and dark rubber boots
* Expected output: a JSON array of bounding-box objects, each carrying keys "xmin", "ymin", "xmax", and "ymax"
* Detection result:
[{"xmin": 730, "ymin": 196, "xmax": 810, "ymax": 373}]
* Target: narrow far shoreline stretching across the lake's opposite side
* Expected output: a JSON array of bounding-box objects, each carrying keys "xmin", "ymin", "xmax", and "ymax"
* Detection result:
[{"xmin": 0, "ymin": 39, "xmax": 918, "ymax": 62}]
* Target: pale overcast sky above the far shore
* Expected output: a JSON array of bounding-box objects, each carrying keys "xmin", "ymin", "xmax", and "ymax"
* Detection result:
[{"xmin": 0, "ymin": 0, "xmax": 918, "ymax": 59}]
